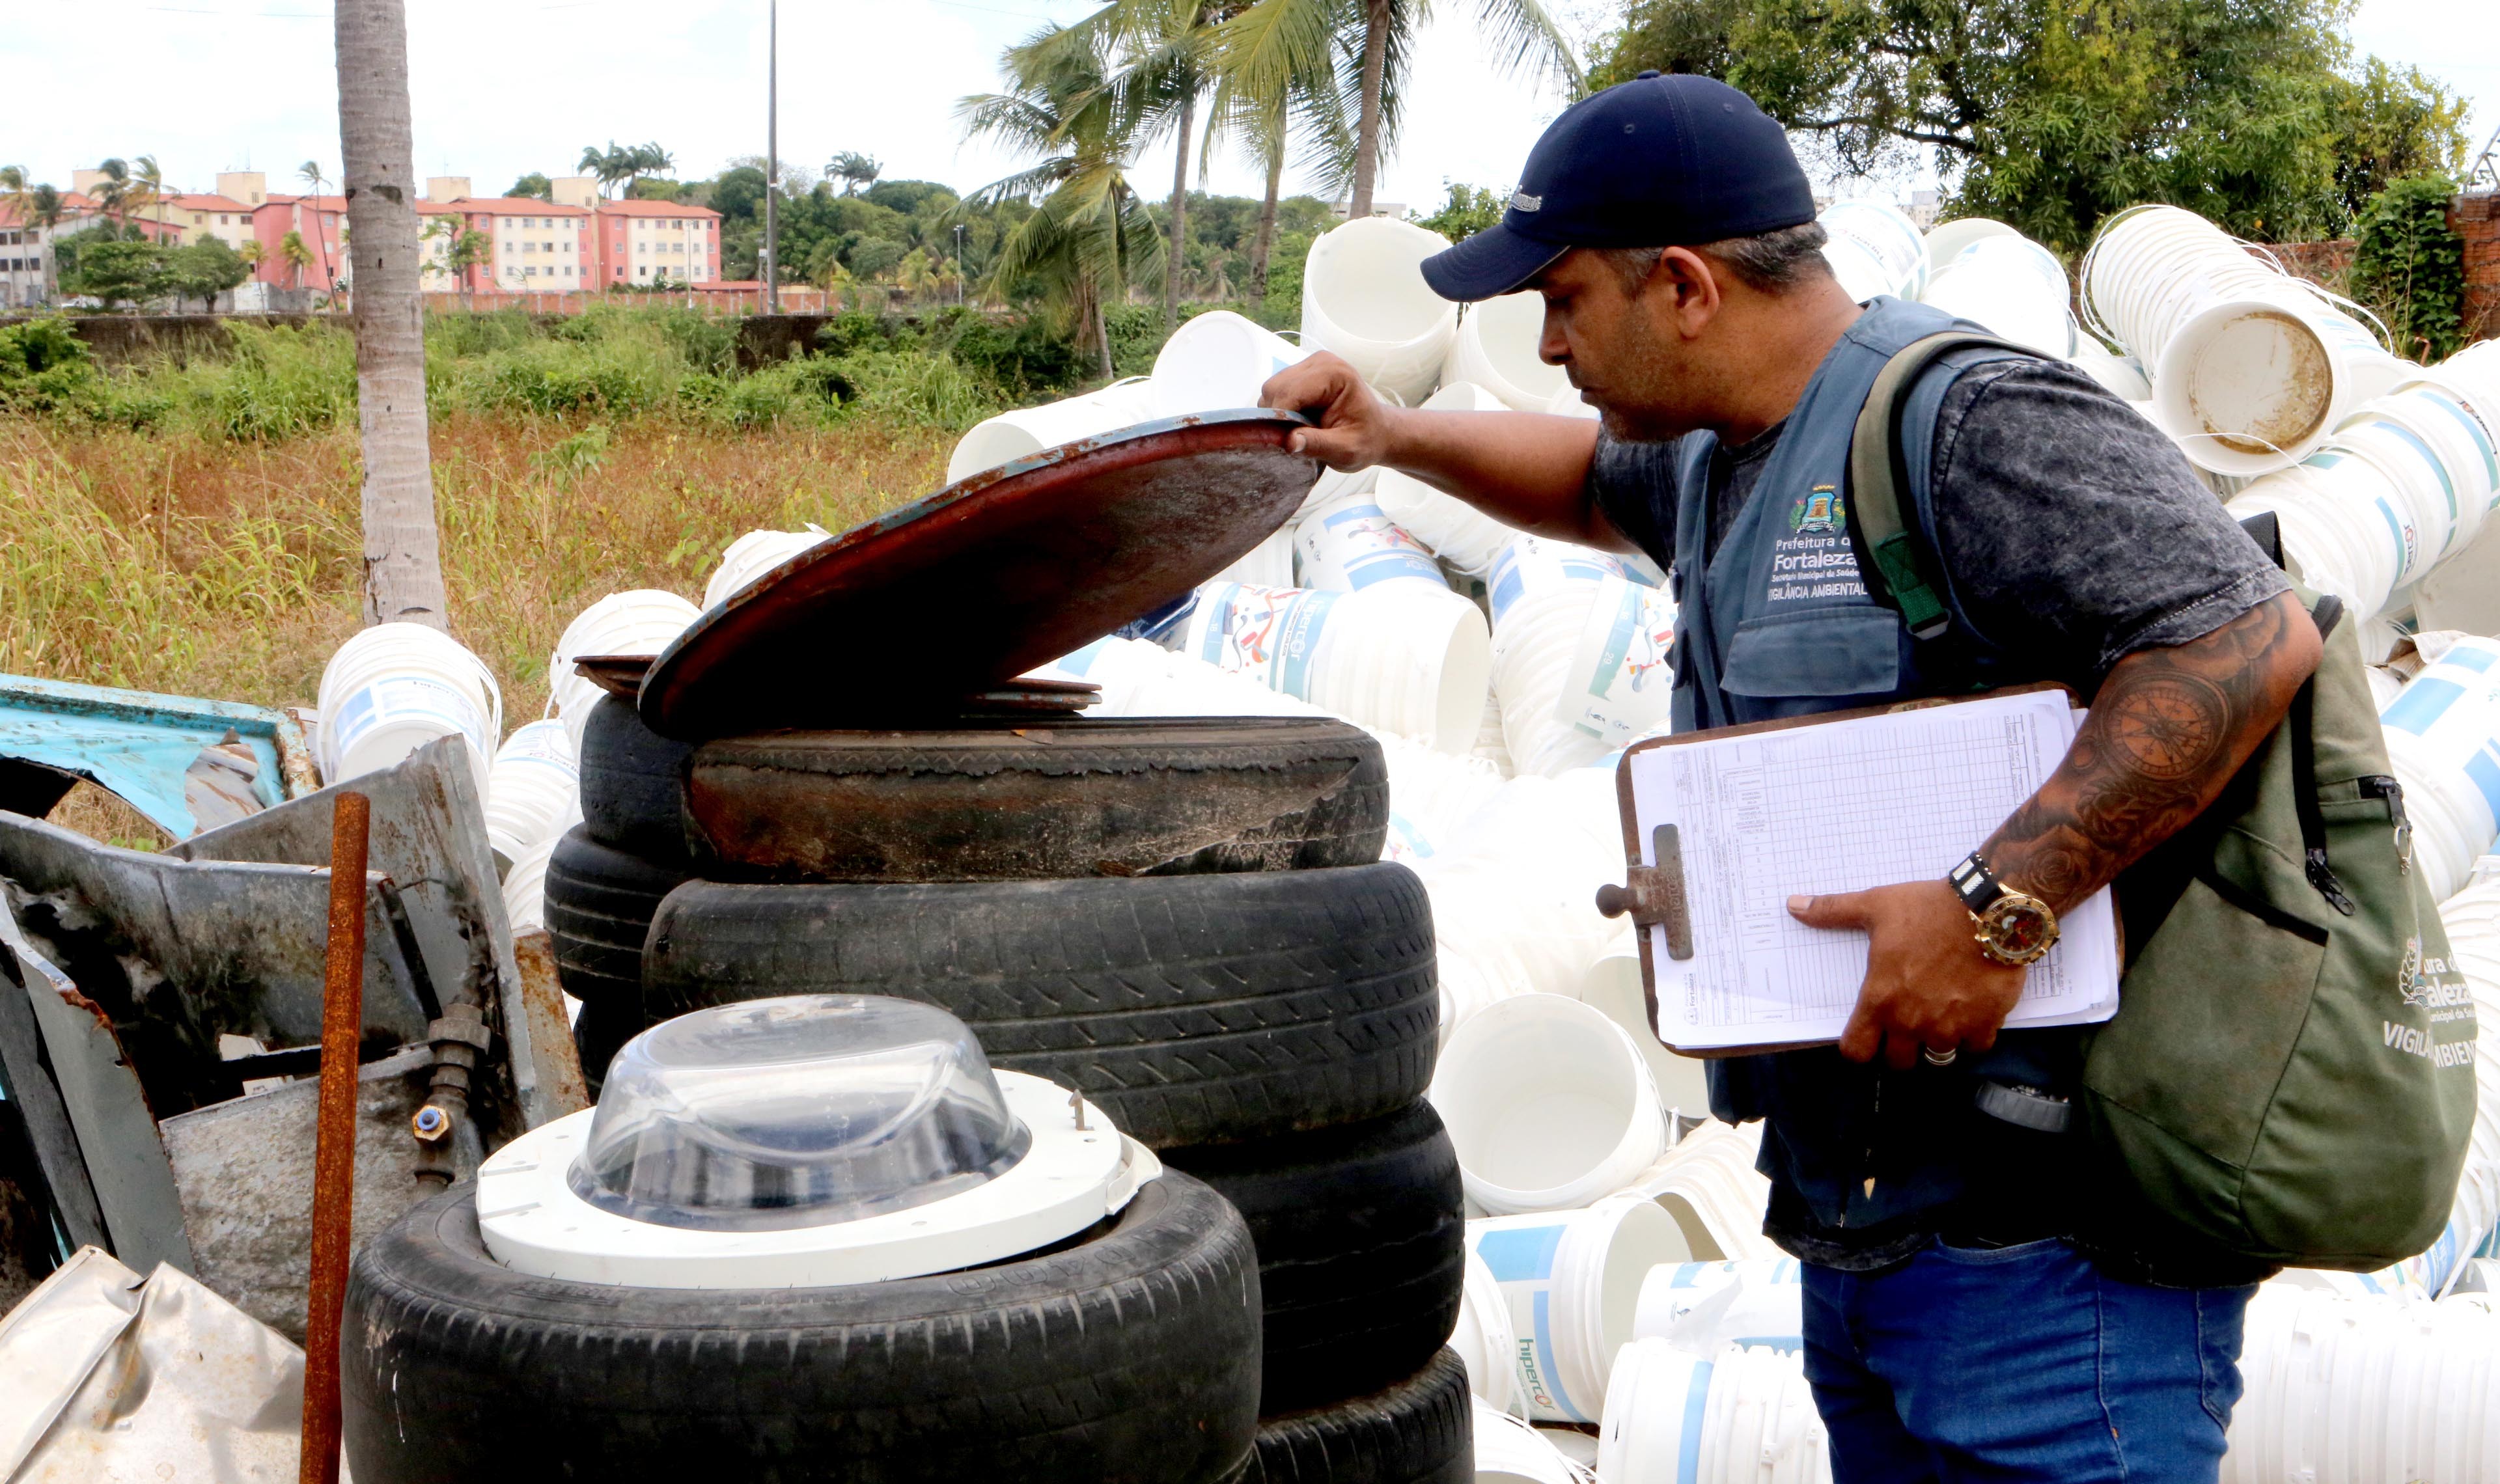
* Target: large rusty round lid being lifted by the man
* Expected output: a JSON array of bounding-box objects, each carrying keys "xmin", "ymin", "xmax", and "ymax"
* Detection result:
[{"xmin": 640, "ymin": 407, "xmax": 1320, "ymax": 742}]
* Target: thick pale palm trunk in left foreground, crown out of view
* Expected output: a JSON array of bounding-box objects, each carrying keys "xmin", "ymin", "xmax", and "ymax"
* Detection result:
[{"xmin": 335, "ymin": 0, "xmax": 450, "ymax": 632}]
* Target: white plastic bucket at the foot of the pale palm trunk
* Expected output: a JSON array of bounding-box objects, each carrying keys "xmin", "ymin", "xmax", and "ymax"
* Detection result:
[{"xmin": 315, "ymin": 625, "xmax": 503, "ymax": 790}]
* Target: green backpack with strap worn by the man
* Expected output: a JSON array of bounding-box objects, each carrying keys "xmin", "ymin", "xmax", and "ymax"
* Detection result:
[{"xmin": 1848, "ymin": 333, "xmax": 2475, "ymax": 1282}]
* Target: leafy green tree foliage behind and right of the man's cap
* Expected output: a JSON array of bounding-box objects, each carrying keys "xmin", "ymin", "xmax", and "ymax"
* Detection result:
[{"xmin": 1590, "ymin": 0, "xmax": 2465, "ymax": 250}]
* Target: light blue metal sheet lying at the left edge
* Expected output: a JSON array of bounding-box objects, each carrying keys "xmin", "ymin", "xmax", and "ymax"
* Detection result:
[{"xmin": 0, "ymin": 674, "xmax": 312, "ymax": 840}]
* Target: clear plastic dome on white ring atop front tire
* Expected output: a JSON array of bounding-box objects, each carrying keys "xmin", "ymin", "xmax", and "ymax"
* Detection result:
[{"xmin": 572, "ymin": 995, "xmax": 1033, "ymax": 1231}]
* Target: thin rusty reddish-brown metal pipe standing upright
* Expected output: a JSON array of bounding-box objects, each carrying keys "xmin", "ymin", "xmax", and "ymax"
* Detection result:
[{"xmin": 295, "ymin": 792, "xmax": 372, "ymax": 1484}]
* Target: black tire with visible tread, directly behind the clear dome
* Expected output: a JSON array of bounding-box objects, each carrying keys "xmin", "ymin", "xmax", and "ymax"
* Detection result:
[{"xmin": 643, "ymin": 862, "xmax": 1440, "ymax": 1149}]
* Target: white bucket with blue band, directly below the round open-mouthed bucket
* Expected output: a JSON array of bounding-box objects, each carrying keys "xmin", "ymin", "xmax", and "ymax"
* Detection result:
[{"xmin": 1467, "ymin": 1197, "xmax": 1682, "ymax": 1422}]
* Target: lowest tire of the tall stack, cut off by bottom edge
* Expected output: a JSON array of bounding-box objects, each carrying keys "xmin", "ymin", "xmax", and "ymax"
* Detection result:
[{"xmin": 1240, "ymin": 1349, "xmax": 1475, "ymax": 1484}]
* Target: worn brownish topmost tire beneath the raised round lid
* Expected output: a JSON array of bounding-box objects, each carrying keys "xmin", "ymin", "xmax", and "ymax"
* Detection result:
[{"xmin": 685, "ymin": 717, "xmax": 1390, "ymax": 882}]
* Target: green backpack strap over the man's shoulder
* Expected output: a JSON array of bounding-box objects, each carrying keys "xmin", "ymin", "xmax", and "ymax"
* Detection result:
[{"xmin": 1842, "ymin": 330, "xmax": 2040, "ymax": 640}]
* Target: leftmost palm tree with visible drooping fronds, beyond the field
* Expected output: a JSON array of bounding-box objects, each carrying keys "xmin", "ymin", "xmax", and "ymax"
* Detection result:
[{"xmin": 955, "ymin": 25, "xmax": 1167, "ymax": 378}]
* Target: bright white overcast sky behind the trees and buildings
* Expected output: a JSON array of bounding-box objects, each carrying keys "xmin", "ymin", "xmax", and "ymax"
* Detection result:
[{"xmin": 0, "ymin": 0, "xmax": 2500, "ymax": 205}]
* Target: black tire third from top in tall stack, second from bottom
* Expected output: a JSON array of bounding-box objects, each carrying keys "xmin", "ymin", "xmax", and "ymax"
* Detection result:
[{"xmin": 1163, "ymin": 1102, "xmax": 1467, "ymax": 1414}]
